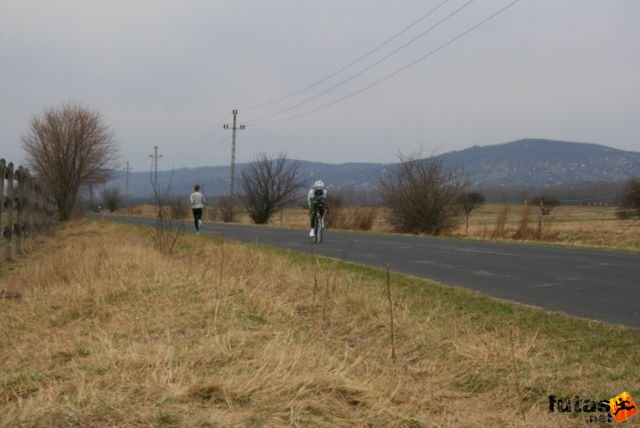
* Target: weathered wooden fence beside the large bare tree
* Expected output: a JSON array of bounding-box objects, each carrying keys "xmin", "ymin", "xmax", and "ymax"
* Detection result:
[{"xmin": 0, "ymin": 159, "xmax": 58, "ymax": 260}]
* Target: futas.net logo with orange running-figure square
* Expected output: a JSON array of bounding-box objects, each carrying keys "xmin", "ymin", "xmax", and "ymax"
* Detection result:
[{"xmin": 549, "ymin": 391, "xmax": 638, "ymax": 423}]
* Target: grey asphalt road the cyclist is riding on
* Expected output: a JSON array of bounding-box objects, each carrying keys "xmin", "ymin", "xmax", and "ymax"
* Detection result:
[{"xmin": 109, "ymin": 217, "xmax": 640, "ymax": 329}]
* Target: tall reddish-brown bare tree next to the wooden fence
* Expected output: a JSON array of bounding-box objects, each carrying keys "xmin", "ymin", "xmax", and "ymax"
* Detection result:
[{"xmin": 22, "ymin": 104, "xmax": 117, "ymax": 220}]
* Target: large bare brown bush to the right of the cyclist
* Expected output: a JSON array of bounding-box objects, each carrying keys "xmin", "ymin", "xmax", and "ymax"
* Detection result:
[{"xmin": 380, "ymin": 154, "xmax": 465, "ymax": 235}]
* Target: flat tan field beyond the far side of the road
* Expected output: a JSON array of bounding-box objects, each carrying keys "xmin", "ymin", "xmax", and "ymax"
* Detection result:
[{"xmin": 116, "ymin": 204, "xmax": 640, "ymax": 251}]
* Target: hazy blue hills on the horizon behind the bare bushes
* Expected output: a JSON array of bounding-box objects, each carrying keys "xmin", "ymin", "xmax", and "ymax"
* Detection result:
[{"xmin": 109, "ymin": 139, "xmax": 640, "ymax": 201}]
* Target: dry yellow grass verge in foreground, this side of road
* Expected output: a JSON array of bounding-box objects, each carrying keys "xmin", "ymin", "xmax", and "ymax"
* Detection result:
[{"xmin": 0, "ymin": 220, "xmax": 640, "ymax": 427}]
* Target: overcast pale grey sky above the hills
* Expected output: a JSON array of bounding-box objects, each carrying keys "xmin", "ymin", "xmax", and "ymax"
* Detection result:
[{"xmin": 0, "ymin": 0, "xmax": 640, "ymax": 171}]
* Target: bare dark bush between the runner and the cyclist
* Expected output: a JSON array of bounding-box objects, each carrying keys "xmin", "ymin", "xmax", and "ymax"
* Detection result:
[{"xmin": 241, "ymin": 153, "xmax": 304, "ymax": 224}]
